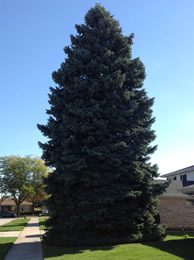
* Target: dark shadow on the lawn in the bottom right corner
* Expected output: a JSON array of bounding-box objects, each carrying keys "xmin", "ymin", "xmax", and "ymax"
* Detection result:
[{"xmin": 142, "ymin": 238, "xmax": 194, "ymax": 260}]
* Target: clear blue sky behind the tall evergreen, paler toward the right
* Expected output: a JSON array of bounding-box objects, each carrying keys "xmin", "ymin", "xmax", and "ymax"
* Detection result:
[{"xmin": 0, "ymin": 0, "xmax": 194, "ymax": 173}]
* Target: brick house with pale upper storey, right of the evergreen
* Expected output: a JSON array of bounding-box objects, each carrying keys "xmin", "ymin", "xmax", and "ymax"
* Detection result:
[{"xmin": 154, "ymin": 166, "xmax": 194, "ymax": 230}]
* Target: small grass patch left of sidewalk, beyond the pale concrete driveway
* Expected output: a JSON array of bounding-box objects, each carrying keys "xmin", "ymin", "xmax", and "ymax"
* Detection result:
[{"xmin": 0, "ymin": 218, "xmax": 30, "ymax": 232}]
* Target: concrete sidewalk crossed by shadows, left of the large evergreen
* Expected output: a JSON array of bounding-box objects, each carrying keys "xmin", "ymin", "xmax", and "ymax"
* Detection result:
[{"xmin": 4, "ymin": 218, "xmax": 43, "ymax": 260}]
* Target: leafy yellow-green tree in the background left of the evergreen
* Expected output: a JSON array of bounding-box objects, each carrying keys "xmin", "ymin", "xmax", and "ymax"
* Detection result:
[{"xmin": 0, "ymin": 156, "xmax": 48, "ymax": 216}]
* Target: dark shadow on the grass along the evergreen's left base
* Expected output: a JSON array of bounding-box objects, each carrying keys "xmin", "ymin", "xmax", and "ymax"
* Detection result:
[{"xmin": 42, "ymin": 243, "xmax": 114, "ymax": 257}]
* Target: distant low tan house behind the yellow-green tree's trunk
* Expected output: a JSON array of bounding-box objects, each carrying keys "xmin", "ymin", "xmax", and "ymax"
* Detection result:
[{"xmin": 0, "ymin": 200, "xmax": 32, "ymax": 213}]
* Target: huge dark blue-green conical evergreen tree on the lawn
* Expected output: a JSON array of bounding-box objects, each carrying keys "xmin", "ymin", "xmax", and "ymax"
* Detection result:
[{"xmin": 38, "ymin": 4, "xmax": 165, "ymax": 246}]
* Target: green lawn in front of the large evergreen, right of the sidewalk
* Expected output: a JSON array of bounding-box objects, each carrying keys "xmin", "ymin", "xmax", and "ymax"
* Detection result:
[{"xmin": 43, "ymin": 232, "xmax": 194, "ymax": 260}]
